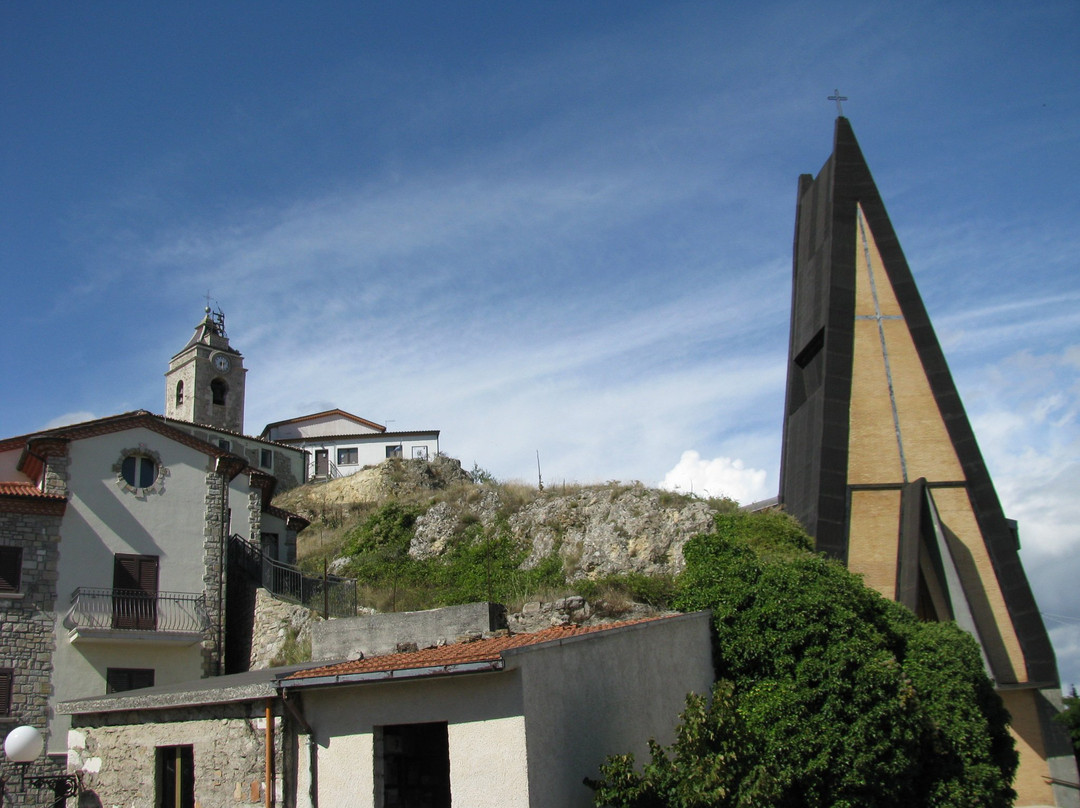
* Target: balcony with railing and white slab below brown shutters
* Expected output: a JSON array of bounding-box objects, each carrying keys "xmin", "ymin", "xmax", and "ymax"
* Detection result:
[{"xmin": 64, "ymin": 587, "xmax": 210, "ymax": 645}]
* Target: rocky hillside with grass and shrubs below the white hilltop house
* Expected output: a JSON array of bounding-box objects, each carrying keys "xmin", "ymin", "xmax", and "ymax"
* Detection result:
[{"xmin": 274, "ymin": 457, "xmax": 735, "ymax": 610}]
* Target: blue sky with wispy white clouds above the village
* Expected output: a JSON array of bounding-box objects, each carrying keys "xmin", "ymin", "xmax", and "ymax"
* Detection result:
[{"xmin": 0, "ymin": 0, "xmax": 1080, "ymax": 684}]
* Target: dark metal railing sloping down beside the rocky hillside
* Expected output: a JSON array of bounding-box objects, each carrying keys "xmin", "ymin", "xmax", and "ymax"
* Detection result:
[{"xmin": 229, "ymin": 534, "xmax": 356, "ymax": 618}]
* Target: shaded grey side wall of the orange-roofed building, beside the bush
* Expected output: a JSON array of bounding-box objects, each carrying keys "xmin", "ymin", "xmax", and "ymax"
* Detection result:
[{"xmin": 514, "ymin": 612, "xmax": 713, "ymax": 808}]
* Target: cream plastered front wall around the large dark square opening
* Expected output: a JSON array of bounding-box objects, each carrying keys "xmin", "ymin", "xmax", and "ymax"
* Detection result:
[{"xmin": 297, "ymin": 672, "xmax": 532, "ymax": 808}]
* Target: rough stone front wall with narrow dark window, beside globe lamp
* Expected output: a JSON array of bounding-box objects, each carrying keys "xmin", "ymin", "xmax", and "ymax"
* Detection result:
[{"xmin": 68, "ymin": 701, "xmax": 286, "ymax": 808}]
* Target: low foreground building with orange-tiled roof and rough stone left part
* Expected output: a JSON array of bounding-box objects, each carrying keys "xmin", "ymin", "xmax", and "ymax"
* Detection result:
[{"xmin": 62, "ymin": 612, "xmax": 713, "ymax": 808}]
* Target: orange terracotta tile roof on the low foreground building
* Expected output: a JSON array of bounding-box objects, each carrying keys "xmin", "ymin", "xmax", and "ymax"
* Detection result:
[{"xmin": 286, "ymin": 617, "xmax": 670, "ymax": 681}]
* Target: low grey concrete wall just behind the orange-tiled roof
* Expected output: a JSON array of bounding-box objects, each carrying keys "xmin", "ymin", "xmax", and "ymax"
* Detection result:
[{"xmin": 311, "ymin": 603, "xmax": 507, "ymax": 660}]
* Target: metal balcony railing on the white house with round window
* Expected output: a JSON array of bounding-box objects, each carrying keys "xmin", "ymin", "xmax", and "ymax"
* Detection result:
[{"xmin": 64, "ymin": 587, "xmax": 210, "ymax": 634}]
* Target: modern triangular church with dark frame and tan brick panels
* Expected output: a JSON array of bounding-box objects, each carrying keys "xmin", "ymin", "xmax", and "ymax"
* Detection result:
[{"xmin": 780, "ymin": 118, "xmax": 1076, "ymax": 805}]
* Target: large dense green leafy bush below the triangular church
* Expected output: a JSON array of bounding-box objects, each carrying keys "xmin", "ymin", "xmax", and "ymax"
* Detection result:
[{"xmin": 597, "ymin": 513, "xmax": 1016, "ymax": 808}]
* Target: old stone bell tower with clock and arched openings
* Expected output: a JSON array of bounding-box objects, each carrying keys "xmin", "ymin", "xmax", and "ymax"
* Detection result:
[{"xmin": 165, "ymin": 306, "xmax": 247, "ymax": 434}]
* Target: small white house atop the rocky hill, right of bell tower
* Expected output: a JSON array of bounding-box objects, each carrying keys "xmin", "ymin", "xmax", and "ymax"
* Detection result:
[{"xmin": 261, "ymin": 409, "xmax": 438, "ymax": 480}]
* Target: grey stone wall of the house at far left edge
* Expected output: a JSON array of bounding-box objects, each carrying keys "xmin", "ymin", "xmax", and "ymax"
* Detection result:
[{"xmin": 0, "ymin": 512, "xmax": 63, "ymax": 806}]
